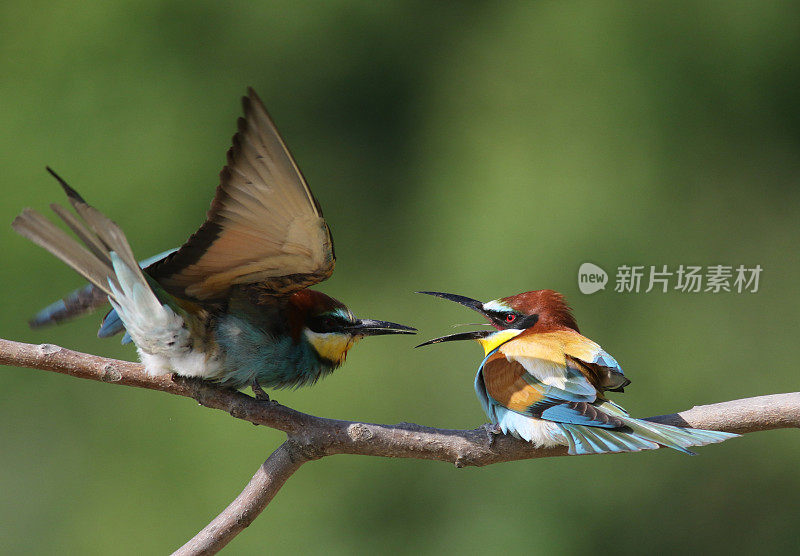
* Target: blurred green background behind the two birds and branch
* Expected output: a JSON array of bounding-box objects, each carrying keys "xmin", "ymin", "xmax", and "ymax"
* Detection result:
[{"xmin": 0, "ymin": 1, "xmax": 800, "ymax": 554}]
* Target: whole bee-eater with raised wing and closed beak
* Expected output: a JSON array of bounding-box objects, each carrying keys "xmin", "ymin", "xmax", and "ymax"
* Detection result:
[{"xmin": 13, "ymin": 89, "xmax": 415, "ymax": 392}]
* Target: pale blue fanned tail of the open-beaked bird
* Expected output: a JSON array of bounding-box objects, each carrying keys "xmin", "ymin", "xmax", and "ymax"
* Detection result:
[{"xmin": 561, "ymin": 401, "xmax": 739, "ymax": 455}]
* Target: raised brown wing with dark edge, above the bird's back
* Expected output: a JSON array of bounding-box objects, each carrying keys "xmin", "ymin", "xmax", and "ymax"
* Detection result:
[{"xmin": 147, "ymin": 89, "xmax": 335, "ymax": 299}]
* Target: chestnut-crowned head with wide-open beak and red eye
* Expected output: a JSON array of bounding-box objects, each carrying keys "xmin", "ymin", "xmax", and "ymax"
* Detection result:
[{"xmin": 417, "ymin": 290, "xmax": 578, "ymax": 354}]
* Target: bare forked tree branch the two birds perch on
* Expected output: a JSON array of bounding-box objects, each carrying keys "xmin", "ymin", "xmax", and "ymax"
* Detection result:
[{"xmin": 0, "ymin": 339, "xmax": 800, "ymax": 554}]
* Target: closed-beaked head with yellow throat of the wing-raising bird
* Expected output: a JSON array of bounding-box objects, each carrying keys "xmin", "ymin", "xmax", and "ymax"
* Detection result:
[{"xmin": 289, "ymin": 289, "xmax": 417, "ymax": 367}]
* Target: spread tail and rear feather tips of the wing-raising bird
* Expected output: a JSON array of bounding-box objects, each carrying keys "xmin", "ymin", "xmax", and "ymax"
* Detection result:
[{"xmin": 11, "ymin": 168, "xmax": 155, "ymax": 336}]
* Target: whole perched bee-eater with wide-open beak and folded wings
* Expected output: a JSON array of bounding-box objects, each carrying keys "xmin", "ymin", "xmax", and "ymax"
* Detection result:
[{"xmin": 417, "ymin": 290, "xmax": 738, "ymax": 454}]
